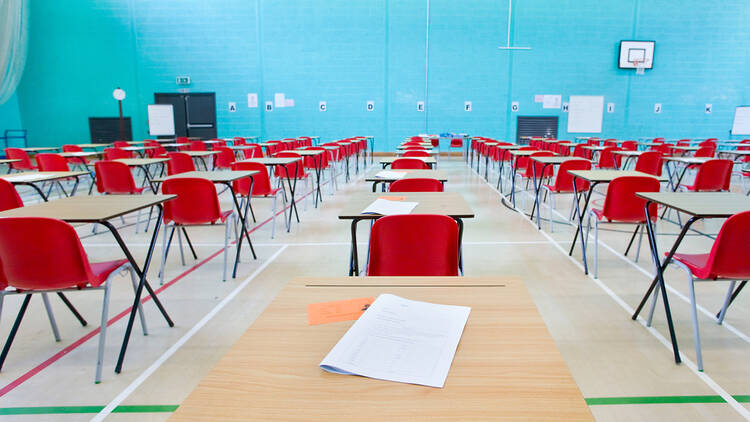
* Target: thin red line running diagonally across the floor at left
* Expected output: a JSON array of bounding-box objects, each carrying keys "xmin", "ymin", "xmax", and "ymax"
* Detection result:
[{"xmin": 0, "ymin": 182, "xmax": 328, "ymax": 397}]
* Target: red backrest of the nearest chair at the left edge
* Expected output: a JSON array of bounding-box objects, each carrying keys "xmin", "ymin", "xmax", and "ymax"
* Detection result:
[{"xmin": 0, "ymin": 217, "xmax": 94, "ymax": 290}]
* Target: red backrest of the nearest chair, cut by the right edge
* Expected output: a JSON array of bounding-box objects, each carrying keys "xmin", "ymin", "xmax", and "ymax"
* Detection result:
[{"xmin": 706, "ymin": 211, "xmax": 750, "ymax": 280}]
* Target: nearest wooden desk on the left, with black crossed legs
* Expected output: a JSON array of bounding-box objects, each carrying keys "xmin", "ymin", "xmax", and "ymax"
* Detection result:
[{"xmin": 0, "ymin": 195, "xmax": 176, "ymax": 373}]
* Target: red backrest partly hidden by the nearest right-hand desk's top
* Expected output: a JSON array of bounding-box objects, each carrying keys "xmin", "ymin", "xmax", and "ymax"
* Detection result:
[{"xmin": 603, "ymin": 176, "xmax": 661, "ymax": 223}]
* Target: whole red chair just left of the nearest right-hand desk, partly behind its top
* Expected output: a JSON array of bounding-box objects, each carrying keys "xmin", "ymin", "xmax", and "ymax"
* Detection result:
[{"xmin": 584, "ymin": 176, "xmax": 661, "ymax": 278}]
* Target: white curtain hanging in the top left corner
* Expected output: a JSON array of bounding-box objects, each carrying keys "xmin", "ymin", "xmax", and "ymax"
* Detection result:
[{"xmin": 0, "ymin": 0, "xmax": 29, "ymax": 104}]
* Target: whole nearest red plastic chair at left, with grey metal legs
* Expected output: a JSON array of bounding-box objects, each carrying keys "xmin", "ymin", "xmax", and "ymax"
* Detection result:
[{"xmin": 0, "ymin": 217, "xmax": 147, "ymax": 383}]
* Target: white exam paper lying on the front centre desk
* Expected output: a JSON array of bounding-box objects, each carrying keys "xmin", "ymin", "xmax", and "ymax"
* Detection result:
[{"xmin": 320, "ymin": 294, "xmax": 471, "ymax": 388}]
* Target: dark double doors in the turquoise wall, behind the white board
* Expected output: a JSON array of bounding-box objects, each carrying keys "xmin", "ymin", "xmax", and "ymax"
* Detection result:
[{"xmin": 154, "ymin": 92, "xmax": 216, "ymax": 138}]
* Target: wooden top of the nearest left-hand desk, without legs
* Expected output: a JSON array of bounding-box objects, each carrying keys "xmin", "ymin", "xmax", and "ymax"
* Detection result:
[{"xmin": 0, "ymin": 195, "xmax": 177, "ymax": 223}]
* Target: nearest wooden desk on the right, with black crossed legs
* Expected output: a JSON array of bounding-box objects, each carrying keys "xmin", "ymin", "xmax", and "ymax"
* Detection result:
[{"xmin": 632, "ymin": 192, "xmax": 750, "ymax": 363}]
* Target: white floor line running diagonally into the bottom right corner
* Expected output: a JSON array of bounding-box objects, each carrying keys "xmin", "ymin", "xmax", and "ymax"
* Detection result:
[{"xmin": 472, "ymin": 164, "xmax": 750, "ymax": 421}]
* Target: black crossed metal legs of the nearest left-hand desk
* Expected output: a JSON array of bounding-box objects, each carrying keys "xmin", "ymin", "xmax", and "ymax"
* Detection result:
[{"xmin": 114, "ymin": 204, "xmax": 174, "ymax": 374}]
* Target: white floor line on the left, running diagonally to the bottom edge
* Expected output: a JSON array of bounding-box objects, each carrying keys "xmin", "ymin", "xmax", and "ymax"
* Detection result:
[{"xmin": 91, "ymin": 246, "xmax": 287, "ymax": 421}]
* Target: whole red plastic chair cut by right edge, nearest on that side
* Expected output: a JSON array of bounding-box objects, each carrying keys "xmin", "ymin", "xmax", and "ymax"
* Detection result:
[{"xmin": 648, "ymin": 211, "xmax": 750, "ymax": 371}]
